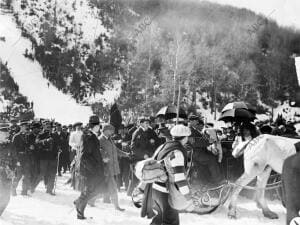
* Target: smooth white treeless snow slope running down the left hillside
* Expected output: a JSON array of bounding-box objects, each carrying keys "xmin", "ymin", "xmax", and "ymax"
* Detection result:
[{"xmin": 0, "ymin": 11, "xmax": 92, "ymax": 124}]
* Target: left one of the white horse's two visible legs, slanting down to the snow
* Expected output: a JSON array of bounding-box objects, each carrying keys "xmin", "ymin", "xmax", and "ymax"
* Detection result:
[{"xmin": 227, "ymin": 173, "xmax": 256, "ymax": 219}]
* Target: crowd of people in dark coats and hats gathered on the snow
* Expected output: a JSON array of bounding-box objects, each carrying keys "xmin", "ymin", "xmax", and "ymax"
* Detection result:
[{"xmin": 0, "ymin": 115, "xmax": 296, "ymax": 224}]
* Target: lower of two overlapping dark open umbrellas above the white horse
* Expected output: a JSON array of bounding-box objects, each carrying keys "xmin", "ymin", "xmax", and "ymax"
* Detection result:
[{"xmin": 219, "ymin": 108, "xmax": 256, "ymax": 122}]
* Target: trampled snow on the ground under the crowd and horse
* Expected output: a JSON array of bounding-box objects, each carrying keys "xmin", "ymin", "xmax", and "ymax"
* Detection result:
[{"xmin": 0, "ymin": 174, "xmax": 285, "ymax": 225}]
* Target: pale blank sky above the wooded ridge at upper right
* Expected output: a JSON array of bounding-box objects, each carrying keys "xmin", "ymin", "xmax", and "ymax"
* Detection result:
[{"xmin": 208, "ymin": 0, "xmax": 300, "ymax": 29}]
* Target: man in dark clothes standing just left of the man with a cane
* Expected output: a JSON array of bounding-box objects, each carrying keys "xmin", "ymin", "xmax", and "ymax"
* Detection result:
[{"xmin": 12, "ymin": 122, "xmax": 31, "ymax": 196}]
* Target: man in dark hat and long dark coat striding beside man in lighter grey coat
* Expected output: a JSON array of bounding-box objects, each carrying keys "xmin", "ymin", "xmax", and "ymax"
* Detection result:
[{"xmin": 74, "ymin": 115, "xmax": 107, "ymax": 220}]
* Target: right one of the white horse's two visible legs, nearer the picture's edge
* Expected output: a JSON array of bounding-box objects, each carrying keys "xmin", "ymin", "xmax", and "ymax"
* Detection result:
[{"xmin": 256, "ymin": 167, "xmax": 278, "ymax": 219}]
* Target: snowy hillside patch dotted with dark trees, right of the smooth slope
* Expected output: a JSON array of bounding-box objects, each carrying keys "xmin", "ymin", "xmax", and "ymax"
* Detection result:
[{"xmin": 12, "ymin": 0, "xmax": 121, "ymax": 105}]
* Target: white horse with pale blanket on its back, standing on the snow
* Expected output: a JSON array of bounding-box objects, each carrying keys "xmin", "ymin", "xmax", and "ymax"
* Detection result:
[{"xmin": 228, "ymin": 134, "xmax": 300, "ymax": 219}]
